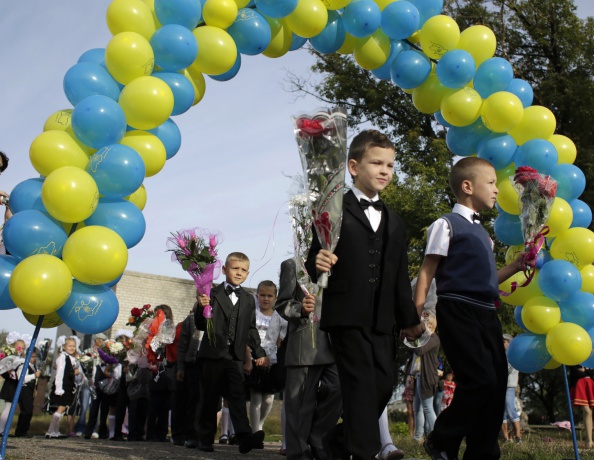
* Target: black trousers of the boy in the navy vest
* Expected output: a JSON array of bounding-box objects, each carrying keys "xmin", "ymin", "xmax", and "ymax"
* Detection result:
[{"xmin": 431, "ymin": 298, "xmax": 507, "ymax": 460}]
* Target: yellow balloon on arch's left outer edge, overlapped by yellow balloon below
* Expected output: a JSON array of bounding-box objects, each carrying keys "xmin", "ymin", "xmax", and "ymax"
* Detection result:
[{"xmin": 29, "ymin": 131, "xmax": 89, "ymax": 176}]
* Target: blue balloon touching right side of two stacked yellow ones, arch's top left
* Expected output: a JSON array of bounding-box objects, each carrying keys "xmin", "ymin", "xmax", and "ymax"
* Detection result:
[{"xmin": 227, "ymin": 8, "xmax": 272, "ymax": 56}]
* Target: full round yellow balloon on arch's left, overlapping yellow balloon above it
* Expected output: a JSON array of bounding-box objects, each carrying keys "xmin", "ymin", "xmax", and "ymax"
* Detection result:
[{"xmin": 41, "ymin": 166, "xmax": 99, "ymax": 223}]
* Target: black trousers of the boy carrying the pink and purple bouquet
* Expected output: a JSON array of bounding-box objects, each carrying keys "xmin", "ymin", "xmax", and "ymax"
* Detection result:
[{"xmin": 198, "ymin": 355, "xmax": 252, "ymax": 445}]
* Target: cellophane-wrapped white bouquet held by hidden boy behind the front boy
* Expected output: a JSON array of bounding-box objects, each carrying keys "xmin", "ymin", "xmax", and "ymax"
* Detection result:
[{"xmin": 289, "ymin": 192, "xmax": 321, "ymax": 348}]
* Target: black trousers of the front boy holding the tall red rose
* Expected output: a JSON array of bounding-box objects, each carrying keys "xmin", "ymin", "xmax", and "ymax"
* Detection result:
[{"xmin": 329, "ymin": 327, "xmax": 396, "ymax": 460}]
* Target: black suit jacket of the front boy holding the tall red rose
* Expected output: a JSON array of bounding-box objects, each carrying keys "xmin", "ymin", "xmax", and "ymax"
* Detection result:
[{"xmin": 306, "ymin": 191, "xmax": 419, "ymax": 334}]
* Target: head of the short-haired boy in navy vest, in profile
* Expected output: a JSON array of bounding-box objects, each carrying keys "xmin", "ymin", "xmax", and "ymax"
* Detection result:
[{"xmin": 450, "ymin": 157, "xmax": 499, "ymax": 211}]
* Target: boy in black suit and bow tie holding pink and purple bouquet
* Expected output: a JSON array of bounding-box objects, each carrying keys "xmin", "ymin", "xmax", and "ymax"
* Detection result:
[{"xmin": 194, "ymin": 252, "xmax": 270, "ymax": 454}]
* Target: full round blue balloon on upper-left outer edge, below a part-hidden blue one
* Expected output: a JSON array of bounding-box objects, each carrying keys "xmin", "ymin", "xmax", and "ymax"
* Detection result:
[{"xmin": 71, "ymin": 96, "xmax": 126, "ymax": 149}]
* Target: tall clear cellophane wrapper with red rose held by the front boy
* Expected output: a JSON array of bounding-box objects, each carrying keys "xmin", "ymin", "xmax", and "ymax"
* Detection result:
[{"xmin": 293, "ymin": 107, "xmax": 347, "ymax": 288}]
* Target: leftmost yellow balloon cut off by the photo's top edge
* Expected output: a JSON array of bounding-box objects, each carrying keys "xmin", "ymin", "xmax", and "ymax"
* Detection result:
[{"xmin": 106, "ymin": 0, "xmax": 155, "ymax": 40}]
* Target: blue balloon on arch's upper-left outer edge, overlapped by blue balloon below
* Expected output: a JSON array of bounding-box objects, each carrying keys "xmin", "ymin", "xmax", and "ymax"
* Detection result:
[{"xmin": 63, "ymin": 62, "xmax": 120, "ymax": 106}]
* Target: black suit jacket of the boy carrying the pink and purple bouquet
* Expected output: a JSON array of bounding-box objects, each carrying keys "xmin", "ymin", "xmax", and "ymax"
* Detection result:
[{"xmin": 194, "ymin": 283, "xmax": 266, "ymax": 360}]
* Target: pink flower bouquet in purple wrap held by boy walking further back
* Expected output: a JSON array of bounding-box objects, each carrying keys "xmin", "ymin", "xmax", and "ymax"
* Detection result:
[{"xmin": 167, "ymin": 227, "xmax": 222, "ymax": 344}]
